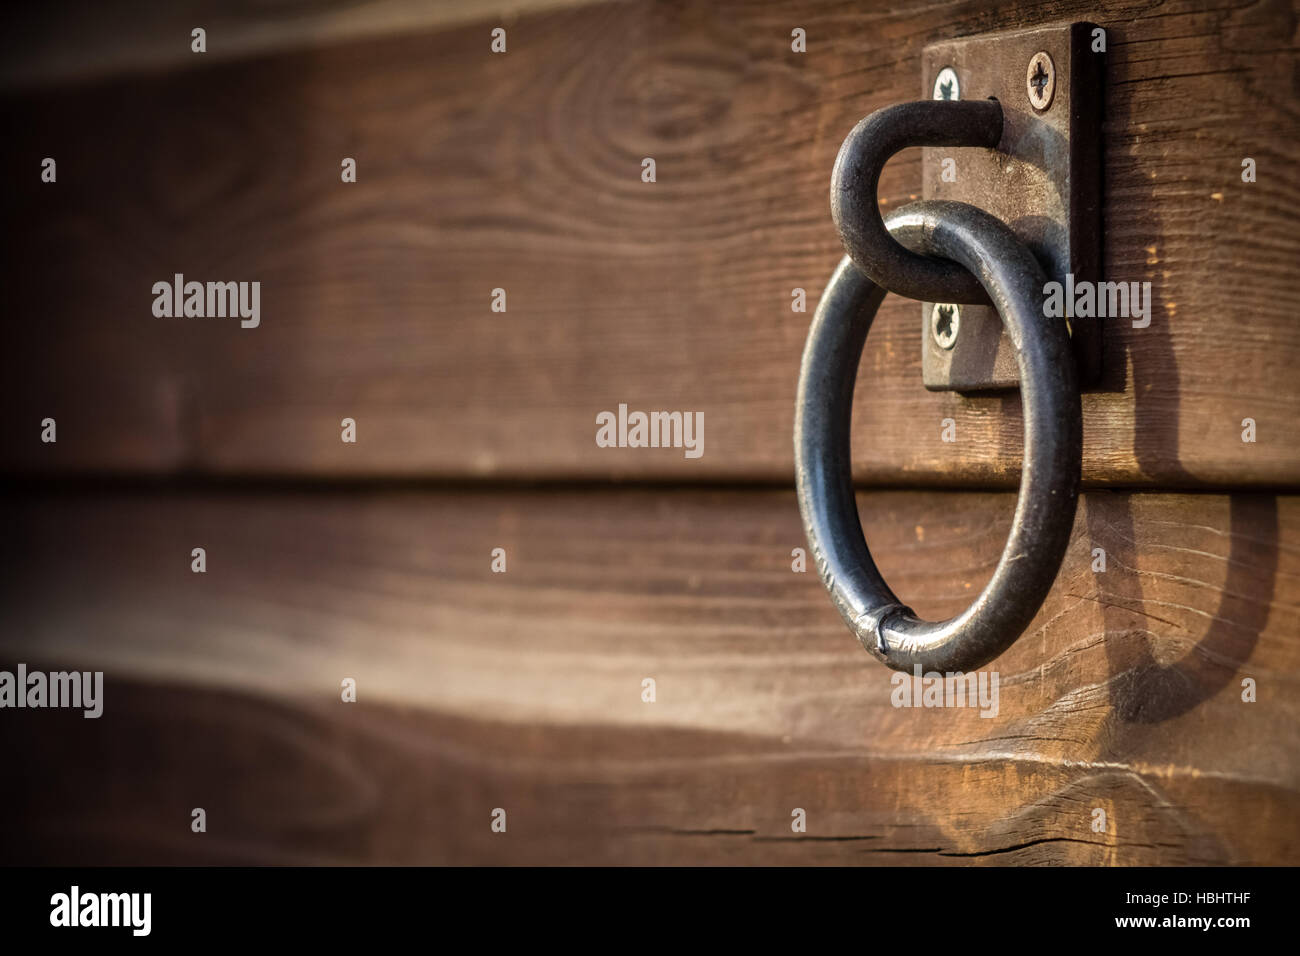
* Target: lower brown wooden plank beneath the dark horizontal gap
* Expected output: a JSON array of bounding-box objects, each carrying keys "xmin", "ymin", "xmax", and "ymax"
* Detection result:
[{"xmin": 0, "ymin": 489, "xmax": 1300, "ymax": 864}]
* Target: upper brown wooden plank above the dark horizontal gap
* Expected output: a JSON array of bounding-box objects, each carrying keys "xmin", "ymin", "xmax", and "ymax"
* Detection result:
[{"xmin": 0, "ymin": 0, "xmax": 1300, "ymax": 488}]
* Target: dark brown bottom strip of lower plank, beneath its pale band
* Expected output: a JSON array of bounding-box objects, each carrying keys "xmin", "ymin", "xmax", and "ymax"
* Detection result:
[{"xmin": 0, "ymin": 682, "xmax": 1297, "ymax": 866}]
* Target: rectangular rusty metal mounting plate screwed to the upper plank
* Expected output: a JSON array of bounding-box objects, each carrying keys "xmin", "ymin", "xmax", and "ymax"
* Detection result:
[{"xmin": 922, "ymin": 23, "xmax": 1105, "ymax": 392}]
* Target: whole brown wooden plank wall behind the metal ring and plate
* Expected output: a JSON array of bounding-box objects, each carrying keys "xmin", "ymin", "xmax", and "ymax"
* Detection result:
[{"xmin": 0, "ymin": 0, "xmax": 1300, "ymax": 864}]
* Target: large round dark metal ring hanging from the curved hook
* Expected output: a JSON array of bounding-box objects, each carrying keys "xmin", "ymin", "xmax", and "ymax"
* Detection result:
[{"xmin": 794, "ymin": 200, "xmax": 1083, "ymax": 671}]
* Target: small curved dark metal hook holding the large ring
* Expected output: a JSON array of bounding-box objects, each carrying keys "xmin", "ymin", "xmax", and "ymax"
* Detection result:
[{"xmin": 831, "ymin": 100, "xmax": 1002, "ymax": 304}]
